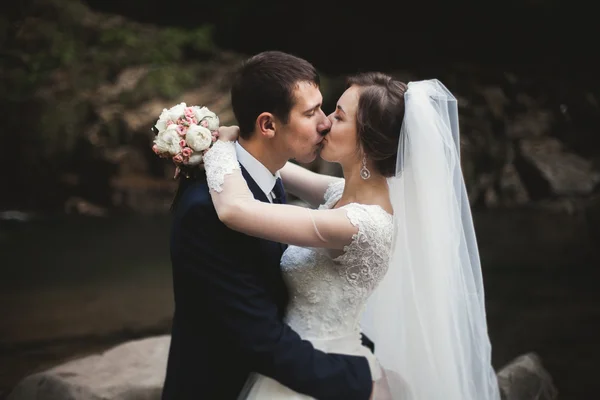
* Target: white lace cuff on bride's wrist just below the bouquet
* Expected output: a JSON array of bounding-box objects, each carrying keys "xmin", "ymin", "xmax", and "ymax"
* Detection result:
[{"xmin": 204, "ymin": 140, "xmax": 240, "ymax": 193}]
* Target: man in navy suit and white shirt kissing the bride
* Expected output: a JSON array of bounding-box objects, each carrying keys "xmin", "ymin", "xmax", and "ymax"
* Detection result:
[{"xmin": 162, "ymin": 52, "xmax": 373, "ymax": 400}]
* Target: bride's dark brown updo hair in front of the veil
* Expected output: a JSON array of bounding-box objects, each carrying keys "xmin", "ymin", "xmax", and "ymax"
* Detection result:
[{"xmin": 346, "ymin": 72, "xmax": 408, "ymax": 177}]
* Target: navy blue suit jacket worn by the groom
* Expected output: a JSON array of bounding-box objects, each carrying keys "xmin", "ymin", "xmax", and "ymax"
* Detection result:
[{"xmin": 162, "ymin": 168, "xmax": 372, "ymax": 400}]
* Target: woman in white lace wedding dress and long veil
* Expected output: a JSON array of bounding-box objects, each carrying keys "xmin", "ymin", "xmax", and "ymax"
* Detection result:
[{"xmin": 205, "ymin": 73, "xmax": 500, "ymax": 400}]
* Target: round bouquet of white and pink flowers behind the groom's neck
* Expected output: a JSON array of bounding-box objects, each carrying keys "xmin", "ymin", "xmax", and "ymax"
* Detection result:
[{"xmin": 152, "ymin": 103, "xmax": 219, "ymax": 177}]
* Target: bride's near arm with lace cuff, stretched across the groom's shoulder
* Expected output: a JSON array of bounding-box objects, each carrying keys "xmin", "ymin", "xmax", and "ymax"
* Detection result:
[{"xmin": 204, "ymin": 140, "xmax": 358, "ymax": 249}]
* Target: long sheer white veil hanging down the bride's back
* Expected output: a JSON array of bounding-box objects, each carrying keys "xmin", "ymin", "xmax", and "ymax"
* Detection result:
[{"xmin": 362, "ymin": 80, "xmax": 500, "ymax": 400}]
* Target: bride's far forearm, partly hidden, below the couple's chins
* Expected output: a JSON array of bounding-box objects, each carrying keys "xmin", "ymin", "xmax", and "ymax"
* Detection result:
[{"xmin": 280, "ymin": 161, "xmax": 343, "ymax": 207}]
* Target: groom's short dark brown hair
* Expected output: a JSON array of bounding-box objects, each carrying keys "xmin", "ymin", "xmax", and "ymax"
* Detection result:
[{"xmin": 231, "ymin": 51, "xmax": 320, "ymax": 139}]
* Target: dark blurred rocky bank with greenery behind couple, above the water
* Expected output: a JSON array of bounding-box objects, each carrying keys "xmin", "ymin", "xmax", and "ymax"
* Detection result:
[{"xmin": 0, "ymin": 0, "xmax": 600, "ymax": 219}]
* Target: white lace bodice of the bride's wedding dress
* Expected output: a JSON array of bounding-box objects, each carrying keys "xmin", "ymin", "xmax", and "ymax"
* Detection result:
[{"xmin": 281, "ymin": 181, "xmax": 393, "ymax": 339}]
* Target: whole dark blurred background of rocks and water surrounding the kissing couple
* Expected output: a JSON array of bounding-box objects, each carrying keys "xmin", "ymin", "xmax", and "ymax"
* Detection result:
[{"xmin": 0, "ymin": 0, "xmax": 600, "ymax": 399}]
